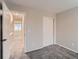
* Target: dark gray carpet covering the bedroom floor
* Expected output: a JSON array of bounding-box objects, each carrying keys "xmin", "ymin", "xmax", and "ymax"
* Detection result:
[{"xmin": 26, "ymin": 45, "xmax": 78, "ymax": 59}]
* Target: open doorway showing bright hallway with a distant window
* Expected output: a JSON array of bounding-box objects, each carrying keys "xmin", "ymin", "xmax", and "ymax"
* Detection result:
[{"xmin": 10, "ymin": 12, "xmax": 24, "ymax": 58}]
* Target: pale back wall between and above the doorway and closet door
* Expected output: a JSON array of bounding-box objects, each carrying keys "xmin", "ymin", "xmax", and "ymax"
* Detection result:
[{"xmin": 7, "ymin": 3, "xmax": 55, "ymax": 51}]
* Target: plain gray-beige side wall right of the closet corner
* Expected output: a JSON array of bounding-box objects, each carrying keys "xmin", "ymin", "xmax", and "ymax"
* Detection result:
[{"xmin": 56, "ymin": 7, "xmax": 78, "ymax": 52}]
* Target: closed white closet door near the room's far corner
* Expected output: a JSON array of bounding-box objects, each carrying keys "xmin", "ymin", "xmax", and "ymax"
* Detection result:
[{"xmin": 43, "ymin": 17, "xmax": 53, "ymax": 47}]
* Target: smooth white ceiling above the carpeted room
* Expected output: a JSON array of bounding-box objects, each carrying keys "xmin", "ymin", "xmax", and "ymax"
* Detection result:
[{"xmin": 4, "ymin": 0, "xmax": 78, "ymax": 13}]
